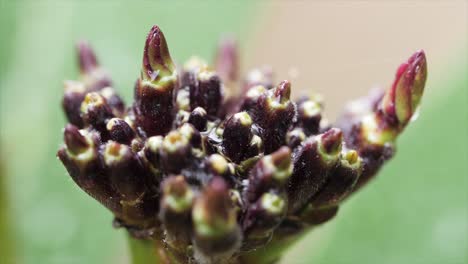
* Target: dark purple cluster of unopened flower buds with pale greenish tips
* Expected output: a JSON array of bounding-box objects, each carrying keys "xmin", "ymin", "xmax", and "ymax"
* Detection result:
[{"xmin": 57, "ymin": 26, "xmax": 427, "ymax": 263}]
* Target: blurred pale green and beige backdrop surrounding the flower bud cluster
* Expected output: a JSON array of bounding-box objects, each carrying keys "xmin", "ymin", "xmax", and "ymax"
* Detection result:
[{"xmin": 0, "ymin": 0, "xmax": 468, "ymax": 264}]
